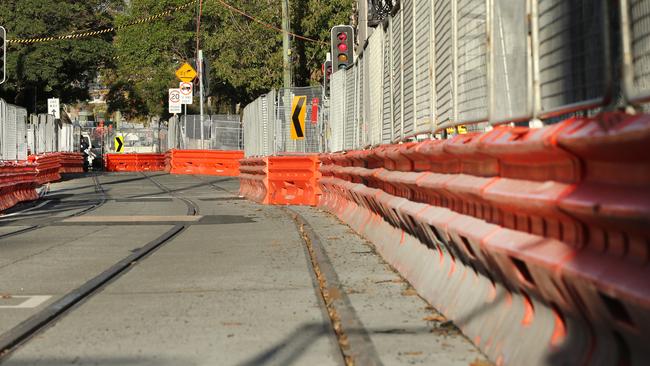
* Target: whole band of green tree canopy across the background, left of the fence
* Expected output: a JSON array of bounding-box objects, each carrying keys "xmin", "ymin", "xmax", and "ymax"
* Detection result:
[{"xmin": 0, "ymin": 0, "xmax": 354, "ymax": 118}]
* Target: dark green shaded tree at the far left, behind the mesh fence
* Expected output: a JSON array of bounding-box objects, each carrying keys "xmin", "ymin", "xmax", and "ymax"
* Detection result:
[{"xmin": 0, "ymin": 0, "xmax": 123, "ymax": 112}]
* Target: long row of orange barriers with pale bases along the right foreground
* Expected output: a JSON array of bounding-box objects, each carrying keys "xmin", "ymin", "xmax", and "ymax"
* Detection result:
[{"xmin": 320, "ymin": 114, "xmax": 650, "ymax": 365}]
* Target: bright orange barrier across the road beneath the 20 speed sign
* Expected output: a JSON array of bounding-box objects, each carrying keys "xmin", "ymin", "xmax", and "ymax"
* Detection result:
[{"xmin": 166, "ymin": 150, "xmax": 244, "ymax": 177}]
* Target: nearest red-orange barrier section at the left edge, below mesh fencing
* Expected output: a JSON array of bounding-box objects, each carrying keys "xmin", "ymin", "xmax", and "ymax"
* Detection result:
[{"xmin": 0, "ymin": 162, "xmax": 38, "ymax": 211}]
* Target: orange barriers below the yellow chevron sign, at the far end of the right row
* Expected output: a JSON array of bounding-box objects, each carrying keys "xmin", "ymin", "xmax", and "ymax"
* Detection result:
[{"xmin": 239, "ymin": 155, "xmax": 321, "ymax": 206}]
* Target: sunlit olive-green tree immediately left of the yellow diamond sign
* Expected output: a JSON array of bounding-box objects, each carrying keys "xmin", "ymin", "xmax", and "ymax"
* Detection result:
[{"xmin": 103, "ymin": 0, "xmax": 196, "ymax": 118}]
